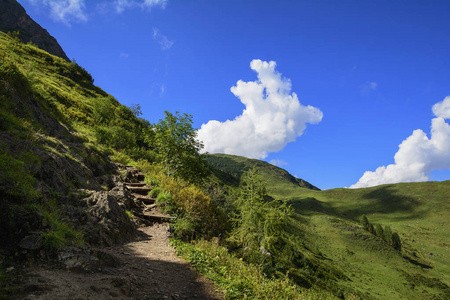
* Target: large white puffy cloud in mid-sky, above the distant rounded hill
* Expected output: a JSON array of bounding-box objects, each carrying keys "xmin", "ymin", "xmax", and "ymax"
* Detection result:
[{"xmin": 198, "ymin": 59, "xmax": 323, "ymax": 158}]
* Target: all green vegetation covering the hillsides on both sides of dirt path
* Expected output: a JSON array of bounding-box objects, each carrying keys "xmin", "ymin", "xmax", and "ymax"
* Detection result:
[{"xmin": 0, "ymin": 27, "xmax": 450, "ymax": 299}]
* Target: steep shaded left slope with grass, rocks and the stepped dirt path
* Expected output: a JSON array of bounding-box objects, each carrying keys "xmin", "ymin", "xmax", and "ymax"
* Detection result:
[{"xmin": 0, "ymin": 27, "xmax": 220, "ymax": 299}]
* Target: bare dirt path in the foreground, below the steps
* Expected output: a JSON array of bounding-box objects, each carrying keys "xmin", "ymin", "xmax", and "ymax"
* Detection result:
[{"xmin": 23, "ymin": 223, "xmax": 222, "ymax": 300}]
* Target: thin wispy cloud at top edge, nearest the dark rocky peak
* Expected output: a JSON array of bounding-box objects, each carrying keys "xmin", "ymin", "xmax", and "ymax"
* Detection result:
[{"xmin": 28, "ymin": 0, "xmax": 88, "ymax": 25}]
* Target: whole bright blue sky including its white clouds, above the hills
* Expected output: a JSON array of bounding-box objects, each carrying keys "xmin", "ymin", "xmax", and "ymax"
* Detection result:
[{"xmin": 19, "ymin": 0, "xmax": 450, "ymax": 189}]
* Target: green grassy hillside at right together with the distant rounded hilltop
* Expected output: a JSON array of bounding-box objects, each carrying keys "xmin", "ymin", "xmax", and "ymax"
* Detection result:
[{"xmin": 207, "ymin": 154, "xmax": 450, "ymax": 299}]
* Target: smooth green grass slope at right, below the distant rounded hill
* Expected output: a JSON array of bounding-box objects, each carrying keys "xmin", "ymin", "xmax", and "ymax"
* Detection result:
[{"xmin": 291, "ymin": 181, "xmax": 450, "ymax": 299}]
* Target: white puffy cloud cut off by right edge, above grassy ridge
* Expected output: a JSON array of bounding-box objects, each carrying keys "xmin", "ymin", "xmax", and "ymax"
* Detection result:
[{"xmin": 350, "ymin": 96, "xmax": 450, "ymax": 188}]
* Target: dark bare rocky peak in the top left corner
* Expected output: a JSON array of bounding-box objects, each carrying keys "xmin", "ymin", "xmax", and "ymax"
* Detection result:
[{"xmin": 0, "ymin": 0, "xmax": 69, "ymax": 61}]
